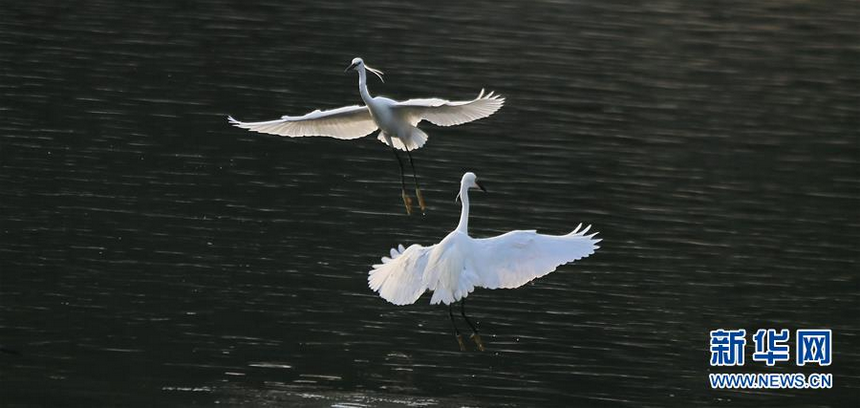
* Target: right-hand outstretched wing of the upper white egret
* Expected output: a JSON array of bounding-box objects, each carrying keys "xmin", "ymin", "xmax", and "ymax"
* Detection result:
[{"xmin": 394, "ymin": 90, "xmax": 505, "ymax": 126}]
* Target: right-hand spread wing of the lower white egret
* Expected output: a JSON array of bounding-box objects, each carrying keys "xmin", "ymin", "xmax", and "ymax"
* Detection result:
[{"xmin": 473, "ymin": 224, "xmax": 600, "ymax": 289}]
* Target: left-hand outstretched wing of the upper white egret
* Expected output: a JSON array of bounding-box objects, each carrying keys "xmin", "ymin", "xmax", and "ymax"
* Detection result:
[{"xmin": 227, "ymin": 105, "xmax": 377, "ymax": 139}]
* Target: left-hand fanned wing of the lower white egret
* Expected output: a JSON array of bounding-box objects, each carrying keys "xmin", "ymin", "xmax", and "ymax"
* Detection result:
[{"xmin": 367, "ymin": 244, "xmax": 434, "ymax": 305}]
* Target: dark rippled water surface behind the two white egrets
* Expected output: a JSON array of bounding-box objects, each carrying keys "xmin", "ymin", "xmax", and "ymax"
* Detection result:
[{"xmin": 0, "ymin": 0, "xmax": 860, "ymax": 406}]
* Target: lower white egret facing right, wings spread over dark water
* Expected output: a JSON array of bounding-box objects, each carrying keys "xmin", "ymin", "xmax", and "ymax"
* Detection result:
[{"xmin": 367, "ymin": 172, "xmax": 601, "ymax": 351}]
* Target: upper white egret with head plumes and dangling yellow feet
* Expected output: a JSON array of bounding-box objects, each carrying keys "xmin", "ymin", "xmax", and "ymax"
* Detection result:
[{"xmin": 227, "ymin": 58, "xmax": 505, "ymax": 214}]
